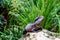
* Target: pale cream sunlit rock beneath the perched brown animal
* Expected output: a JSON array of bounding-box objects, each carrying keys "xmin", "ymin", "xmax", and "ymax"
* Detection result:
[{"xmin": 19, "ymin": 29, "xmax": 60, "ymax": 40}]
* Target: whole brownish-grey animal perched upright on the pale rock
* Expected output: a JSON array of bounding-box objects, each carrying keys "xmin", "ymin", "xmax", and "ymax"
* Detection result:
[{"xmin": 23, "ymin": 16, "xmax": 44, "ymax": 34}]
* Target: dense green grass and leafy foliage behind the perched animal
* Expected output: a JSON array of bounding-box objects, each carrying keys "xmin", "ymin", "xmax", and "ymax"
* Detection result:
[{"xmin": 0, "ymin": 0, "xmax": 60, "ymax": 40}]
